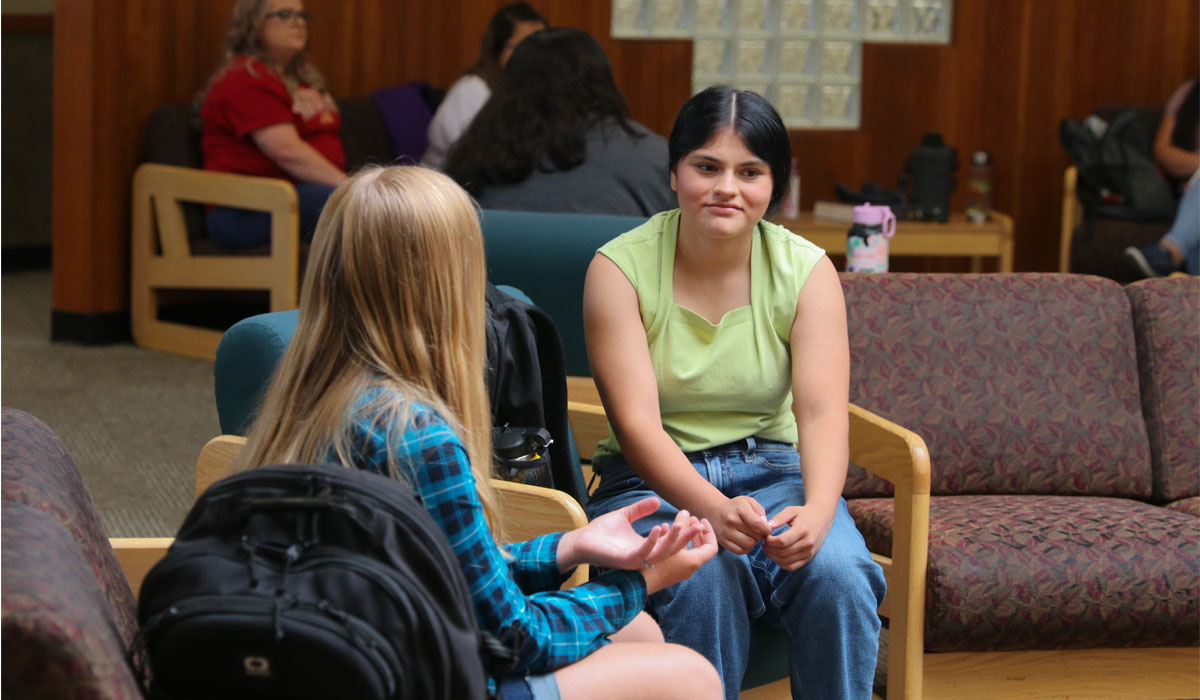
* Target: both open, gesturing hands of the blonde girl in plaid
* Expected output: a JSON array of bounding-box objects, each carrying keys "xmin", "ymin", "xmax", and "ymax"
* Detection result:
[{"xmin": 558, "ymin": 496, "xmax": 716, "ymax": 593}]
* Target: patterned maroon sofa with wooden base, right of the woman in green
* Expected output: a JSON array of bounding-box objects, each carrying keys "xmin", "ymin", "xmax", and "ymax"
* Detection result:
[{"xmin": 842, "ymin": 274, "xmax": 1200, "ymax": 698}]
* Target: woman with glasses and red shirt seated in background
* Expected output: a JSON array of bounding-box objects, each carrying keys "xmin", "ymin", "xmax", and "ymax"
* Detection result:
[{"xmin": 199, "ymin": 0, "xmax": 346, "ymax": 249}]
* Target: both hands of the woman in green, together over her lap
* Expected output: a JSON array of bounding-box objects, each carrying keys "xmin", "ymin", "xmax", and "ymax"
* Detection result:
[{"xmin": 710, "ymin": 496, "xmax": 833, "ymax": 570}]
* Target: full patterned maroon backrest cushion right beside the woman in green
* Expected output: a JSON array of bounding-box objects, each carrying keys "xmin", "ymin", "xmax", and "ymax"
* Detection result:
[{"xmin": 842, "ymin": 272, "xmax": 1151, "ymax": 498}]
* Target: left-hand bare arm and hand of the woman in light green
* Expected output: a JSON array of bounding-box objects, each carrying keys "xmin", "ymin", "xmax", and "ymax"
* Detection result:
[{"xmin": 583, "ymin": 255, "xmax": 769, "ymax": 554}]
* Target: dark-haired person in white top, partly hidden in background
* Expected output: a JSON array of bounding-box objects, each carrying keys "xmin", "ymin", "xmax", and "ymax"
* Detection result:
[{"xmin": 421, "ymin": 2, "xmax": 546, "ymax": 168}]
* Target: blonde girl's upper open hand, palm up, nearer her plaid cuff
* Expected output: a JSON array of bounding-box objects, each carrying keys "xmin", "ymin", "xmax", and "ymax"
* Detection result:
[{"xmin": 558, "ymin": 497, "xmax": 703, "ymax": 572}]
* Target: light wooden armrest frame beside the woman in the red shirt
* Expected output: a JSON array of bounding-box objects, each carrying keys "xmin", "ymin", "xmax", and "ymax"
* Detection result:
[{"xmin": 130, "ymin": 163, "xmax": 300, "ymax": 360}]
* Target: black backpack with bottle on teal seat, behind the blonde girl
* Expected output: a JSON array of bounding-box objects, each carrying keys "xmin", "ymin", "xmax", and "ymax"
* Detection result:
[{"xmin": 485, "ymin": 282, "xmax": 587, "ymax": 503}]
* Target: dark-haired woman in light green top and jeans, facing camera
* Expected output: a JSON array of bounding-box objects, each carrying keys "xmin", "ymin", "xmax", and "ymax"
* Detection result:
[{"xmin": 583, "ymin": 85, "xmax": 886, "ymax": 700}]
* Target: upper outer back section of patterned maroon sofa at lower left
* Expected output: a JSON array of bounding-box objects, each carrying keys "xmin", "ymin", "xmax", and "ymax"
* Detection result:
[{"xmin": 0, "ymin": 408, "xmax": 137, "ymax": 644}]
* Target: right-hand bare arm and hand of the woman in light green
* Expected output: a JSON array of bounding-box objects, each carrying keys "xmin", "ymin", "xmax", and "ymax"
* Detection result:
[{"xmin": 763, "ymin": 258, "xmax": 850, "ymax": 569}]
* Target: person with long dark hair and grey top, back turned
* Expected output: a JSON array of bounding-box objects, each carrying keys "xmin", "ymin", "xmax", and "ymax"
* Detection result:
[{"xmin": 445, "ymin": 28, "xmax": 674, "ymax": 216}]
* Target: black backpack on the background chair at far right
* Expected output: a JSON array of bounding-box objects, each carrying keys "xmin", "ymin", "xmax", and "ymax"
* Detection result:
[{"xmin": 1058, "ymin": 107, "xmax": 1176, "ymax": 221}]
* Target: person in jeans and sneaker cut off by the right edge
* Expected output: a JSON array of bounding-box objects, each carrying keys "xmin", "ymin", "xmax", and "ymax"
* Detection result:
[{"xmin": 1124, "ymin": 73, "xmax": 1200, "ymax": 277}]
